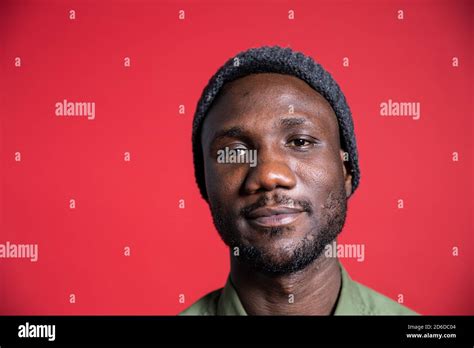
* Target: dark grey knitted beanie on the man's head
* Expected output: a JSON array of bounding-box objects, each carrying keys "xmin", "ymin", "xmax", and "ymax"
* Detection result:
[{"xmin": 192, "ymin": 46, "xmax": 360, "ymax": 201}]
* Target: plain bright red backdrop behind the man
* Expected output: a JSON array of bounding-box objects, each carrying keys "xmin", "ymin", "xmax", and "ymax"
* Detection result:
[{"xmin": 0, "ymin": 1, "xmax": 474, "ymax": 315}]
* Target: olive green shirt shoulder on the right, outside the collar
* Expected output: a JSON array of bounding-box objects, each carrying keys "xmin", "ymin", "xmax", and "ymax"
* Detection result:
[{"xmin": 353, "ymin": 281, "xmax": 419, "ymax": 315}]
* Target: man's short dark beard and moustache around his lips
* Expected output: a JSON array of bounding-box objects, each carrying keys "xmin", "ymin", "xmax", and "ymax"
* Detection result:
[{"xmin": 210, "ymin": 187, "xmax": 347, "ymax": 276}]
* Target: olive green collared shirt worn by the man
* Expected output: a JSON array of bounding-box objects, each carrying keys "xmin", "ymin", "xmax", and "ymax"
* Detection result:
[{"xmin": 180, "ymin": 263, "xmax": 418, "ymax": 315}]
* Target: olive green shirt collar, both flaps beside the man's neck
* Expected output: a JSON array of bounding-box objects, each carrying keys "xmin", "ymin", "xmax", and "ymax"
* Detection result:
[{"xmin": 217, "ymin": 262, "xmax": 366, "ymax": 315}]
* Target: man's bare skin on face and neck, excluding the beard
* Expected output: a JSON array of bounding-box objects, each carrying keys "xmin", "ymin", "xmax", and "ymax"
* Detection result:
[{"xmin": 201, "ymin": 73, "xmax": 352, "ymax": 315}]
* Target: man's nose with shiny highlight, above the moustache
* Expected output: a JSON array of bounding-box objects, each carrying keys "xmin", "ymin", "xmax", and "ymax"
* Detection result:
[{"xmin": 244, "ymin": 155, "xmax": 296, "ymax": 194}]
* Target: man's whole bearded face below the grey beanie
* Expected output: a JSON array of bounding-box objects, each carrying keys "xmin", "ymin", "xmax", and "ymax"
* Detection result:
[{"xmin": 201, "ymin": 73, "xmax": 351, "ymax": 275}]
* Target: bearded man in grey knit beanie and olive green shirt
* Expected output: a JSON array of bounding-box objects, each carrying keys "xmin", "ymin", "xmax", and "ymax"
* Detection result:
[{"xmin": 181, "ymin": 47, "xmax": 416, "ymax": 315}]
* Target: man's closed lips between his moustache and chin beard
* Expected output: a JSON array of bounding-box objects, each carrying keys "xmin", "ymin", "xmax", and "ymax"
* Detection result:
[{"xmin": 246, "ymin": 206, "xmax": 303, "ymax": 227}]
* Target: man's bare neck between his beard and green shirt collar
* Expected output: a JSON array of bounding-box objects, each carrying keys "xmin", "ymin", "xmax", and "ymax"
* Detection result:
[{"xmin": 231, "ymin": 254, "xmax": 341, "ymax": 315}]
